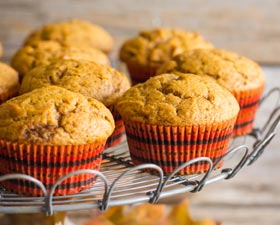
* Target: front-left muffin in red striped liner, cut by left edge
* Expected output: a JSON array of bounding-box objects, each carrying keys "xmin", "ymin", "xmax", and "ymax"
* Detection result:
[{"xmin": 0, "ymin": 86, "xmax": 114, "ymax": 196}]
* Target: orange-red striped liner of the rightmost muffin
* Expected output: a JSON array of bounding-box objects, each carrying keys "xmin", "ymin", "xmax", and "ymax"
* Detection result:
[{"xmin": 233, "ymin": 85, "xmax": 264, "ymax": 136}]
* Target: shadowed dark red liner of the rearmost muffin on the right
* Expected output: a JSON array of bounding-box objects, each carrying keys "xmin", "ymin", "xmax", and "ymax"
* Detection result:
[{"xmin": 126, "ymin": 64, "xmax": 158, "ymax": 85}]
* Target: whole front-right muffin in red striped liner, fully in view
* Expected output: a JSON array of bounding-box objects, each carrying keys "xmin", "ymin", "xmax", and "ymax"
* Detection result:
[{"xmin": 116, "ymin": 74, "xmax": 239, "ymax": 174}]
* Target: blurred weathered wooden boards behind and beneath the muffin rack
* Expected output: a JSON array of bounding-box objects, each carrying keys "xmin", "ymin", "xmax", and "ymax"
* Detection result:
[{"xmin": 0, "ymin": 0, "xmax": 280, "ymax": 225}]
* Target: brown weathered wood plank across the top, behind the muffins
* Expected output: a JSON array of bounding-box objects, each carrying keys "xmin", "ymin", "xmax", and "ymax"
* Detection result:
[{"xmin": 0, "ymin": 0, "xmax": 280, "ymax": 64}]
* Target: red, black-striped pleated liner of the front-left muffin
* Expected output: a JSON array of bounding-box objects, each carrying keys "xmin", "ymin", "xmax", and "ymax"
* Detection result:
[{"xmin": 0, "ymin": 140, "xmax": 105, "ymax": 196}]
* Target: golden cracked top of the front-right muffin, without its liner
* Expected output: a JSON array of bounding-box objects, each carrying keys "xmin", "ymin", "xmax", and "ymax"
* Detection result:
[{"xmin": 116, "ymin": 74, "xmax": 239, "ymax": 126}]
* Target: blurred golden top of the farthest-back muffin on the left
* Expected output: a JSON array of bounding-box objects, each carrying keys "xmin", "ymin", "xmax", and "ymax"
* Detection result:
[{"xmin": 25, "ymin": 19, "xmax": 113, "ymax": 53}]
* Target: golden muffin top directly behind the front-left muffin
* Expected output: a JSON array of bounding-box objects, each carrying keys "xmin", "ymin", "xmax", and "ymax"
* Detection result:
[{"xmin": 20, "ymin": 60, "xmax": 130, "ymax": 106}]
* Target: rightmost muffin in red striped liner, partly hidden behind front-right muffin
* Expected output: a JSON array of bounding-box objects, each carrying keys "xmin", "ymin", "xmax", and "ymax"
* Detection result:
[{"xmin": 158, "ymin": 49, "xmax": 265, "ymax": 135}]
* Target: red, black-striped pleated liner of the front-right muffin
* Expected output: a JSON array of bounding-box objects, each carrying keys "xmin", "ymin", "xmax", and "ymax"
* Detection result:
[{"xmin": 124, "ymin": 118, "xmax": 236, "ymax": 175}]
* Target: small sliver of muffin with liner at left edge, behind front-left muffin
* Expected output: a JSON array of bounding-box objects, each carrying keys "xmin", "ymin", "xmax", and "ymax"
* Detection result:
[{"xmin": 0, "ymin": 62, "xmax": 19, "ymax": 104}]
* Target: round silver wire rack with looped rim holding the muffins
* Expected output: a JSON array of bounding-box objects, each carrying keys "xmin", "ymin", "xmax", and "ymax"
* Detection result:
[{"xmin": 0, "ymin": 88, "xmax": 280, "ymax": 215}]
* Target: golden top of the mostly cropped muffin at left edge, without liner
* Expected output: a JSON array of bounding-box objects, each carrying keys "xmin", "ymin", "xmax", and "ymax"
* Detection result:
[{"xmin": 0, "ymin": 62, "xmax": 19, "ymax": 95}]
